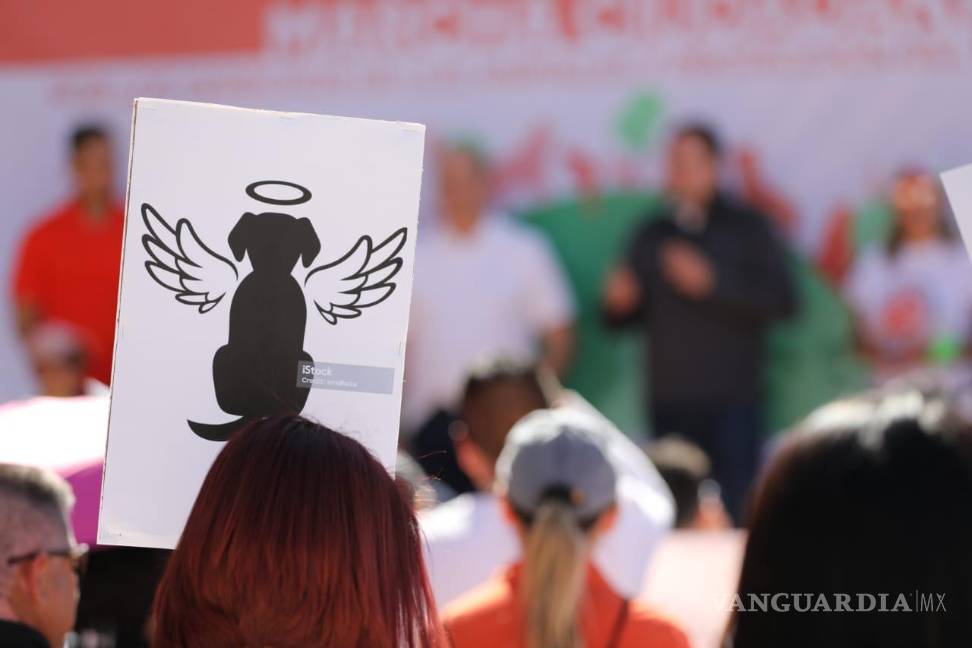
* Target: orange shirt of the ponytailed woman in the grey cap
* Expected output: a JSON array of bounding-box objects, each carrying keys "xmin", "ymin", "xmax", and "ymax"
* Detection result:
[{"xmin": 443, "ymin": 565, "xmax": 689, "ymax": 648}]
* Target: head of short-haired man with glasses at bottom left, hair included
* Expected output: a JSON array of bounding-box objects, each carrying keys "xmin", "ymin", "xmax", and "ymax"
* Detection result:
[{"xmin": 0, "ymin": 464, "xmax": 87, "ymax": 648}]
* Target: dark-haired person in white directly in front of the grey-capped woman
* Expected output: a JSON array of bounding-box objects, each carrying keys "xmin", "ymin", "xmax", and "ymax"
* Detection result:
[{"xmin": 419, "ymin": 359, "xmax": 674, "ymax": 606}]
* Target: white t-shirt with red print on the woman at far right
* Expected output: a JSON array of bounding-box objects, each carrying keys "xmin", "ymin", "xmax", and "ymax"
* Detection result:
[{"xmin": 845, "ymin": 240, "xmax": 972, "ymax": 355}]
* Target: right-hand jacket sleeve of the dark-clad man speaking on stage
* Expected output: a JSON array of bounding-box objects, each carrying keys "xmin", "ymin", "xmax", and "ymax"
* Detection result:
[{"xmin": 711, "ymin": 214, "xmax": 797, "ymax": 323}]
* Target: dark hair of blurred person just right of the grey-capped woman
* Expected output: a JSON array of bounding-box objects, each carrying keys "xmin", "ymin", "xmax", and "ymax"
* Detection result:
[{"xmin": 646, "ymin": 437, "xmax": 712, "ymax": 528}]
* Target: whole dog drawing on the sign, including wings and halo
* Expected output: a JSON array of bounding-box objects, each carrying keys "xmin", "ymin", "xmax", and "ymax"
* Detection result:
[{"xmin": 141, "ymin": 180, "xmax": 408, "ymax": 441}]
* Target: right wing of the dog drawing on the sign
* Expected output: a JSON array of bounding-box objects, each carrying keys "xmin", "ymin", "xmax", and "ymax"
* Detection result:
[{"xmin": 304, "ymin": 227, "xmax": 408, "ymax": 324}]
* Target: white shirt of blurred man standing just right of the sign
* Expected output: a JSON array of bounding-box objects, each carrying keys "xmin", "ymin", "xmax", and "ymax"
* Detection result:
[{"xmin": 403, "ymin": 214, "xmax": 574, "ymax": 430}]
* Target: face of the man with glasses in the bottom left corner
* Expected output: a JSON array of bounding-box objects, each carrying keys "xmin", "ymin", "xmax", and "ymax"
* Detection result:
[{"xmin": 9, "ymin": 531, "xmax": 79, "ymax": 647}]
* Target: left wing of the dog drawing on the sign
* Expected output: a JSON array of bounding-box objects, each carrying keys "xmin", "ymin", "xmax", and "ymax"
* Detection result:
[{"xmin": 142, "ymin": 203, "xmax": 239, "ymax": 313}]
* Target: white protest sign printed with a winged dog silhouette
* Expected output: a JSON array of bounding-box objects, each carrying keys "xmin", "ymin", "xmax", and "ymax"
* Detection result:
[{"xmin": 98, "ymin": 99, "xmax": 425, "ymax": 547}]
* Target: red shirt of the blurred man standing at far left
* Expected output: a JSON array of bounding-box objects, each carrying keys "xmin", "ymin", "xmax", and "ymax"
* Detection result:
[{"xmin": 13, "ymin": 201, "xmax": 125, "ymax": 384}]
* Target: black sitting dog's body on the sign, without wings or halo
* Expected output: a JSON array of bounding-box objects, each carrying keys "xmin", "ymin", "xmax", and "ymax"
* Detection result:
[{"xmin": 189, "ymin": 212, "xmax": 321, "ymax": 441}]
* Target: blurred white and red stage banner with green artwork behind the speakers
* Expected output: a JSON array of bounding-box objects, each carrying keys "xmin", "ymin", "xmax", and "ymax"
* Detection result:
[{"xmin": 0, "ymin": 0, "xmax": 972, "ymax": 430}]
